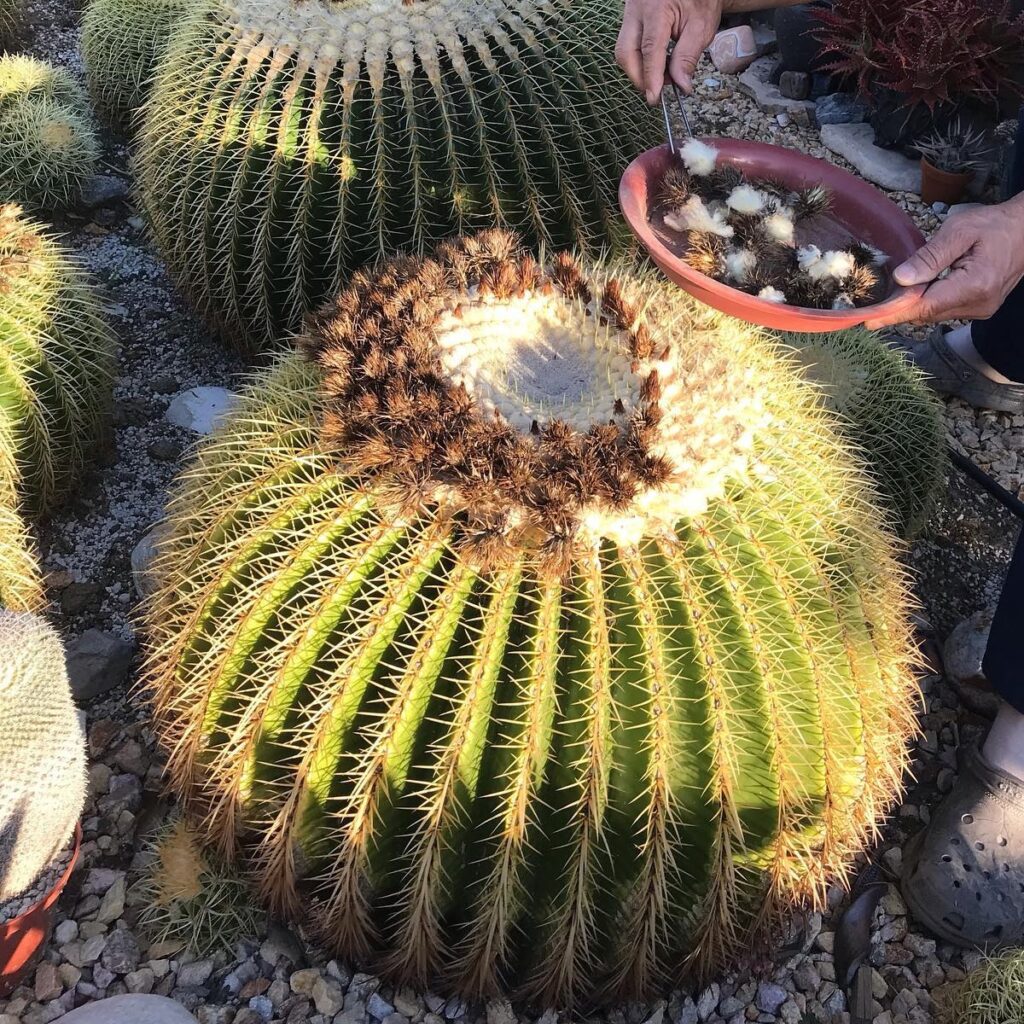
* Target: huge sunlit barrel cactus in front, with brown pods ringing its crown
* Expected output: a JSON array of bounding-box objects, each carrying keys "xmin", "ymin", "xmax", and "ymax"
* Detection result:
[{"xmin": 147, "ymin": 232, "xmax": 914, "ymax": 1001}]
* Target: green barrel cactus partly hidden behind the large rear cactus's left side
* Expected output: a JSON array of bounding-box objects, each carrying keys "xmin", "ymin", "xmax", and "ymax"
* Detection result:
[{"xmin": 82, "ymin": 0, "xmax": 189, "ymax": 124}]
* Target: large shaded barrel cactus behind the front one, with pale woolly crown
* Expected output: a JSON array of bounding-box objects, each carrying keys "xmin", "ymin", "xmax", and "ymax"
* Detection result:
[{"xmin": 138, "ymin": 0, "xmax": 660, "ymax": 349}]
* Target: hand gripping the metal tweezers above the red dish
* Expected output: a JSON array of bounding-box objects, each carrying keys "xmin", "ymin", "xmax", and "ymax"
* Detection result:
[{"xmin": 615, "ymin": 0, "xmax": 723, "ymax": 104}]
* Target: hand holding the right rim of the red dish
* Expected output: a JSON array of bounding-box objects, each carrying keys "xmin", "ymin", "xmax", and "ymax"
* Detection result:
[{"xmin": 866, "ymin": 198, "xmax": 1024, "ymax": 328}]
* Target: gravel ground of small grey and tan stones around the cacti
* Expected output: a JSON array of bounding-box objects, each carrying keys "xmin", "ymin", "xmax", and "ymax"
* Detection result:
[{"xmin": 0, "ymin": 8, "xmax": 1024, "ymax": 1024}]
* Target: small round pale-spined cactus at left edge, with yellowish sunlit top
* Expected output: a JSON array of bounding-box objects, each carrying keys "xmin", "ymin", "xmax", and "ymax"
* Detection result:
[{"xmin": 0, "ymin": 54, "xmax": 99, "ymax": 209}]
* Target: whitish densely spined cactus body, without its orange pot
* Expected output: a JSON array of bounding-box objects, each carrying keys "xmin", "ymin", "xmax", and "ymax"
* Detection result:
[{"xmin": 0, "ymin": 611, "xmax": 85, "ymax": 902}]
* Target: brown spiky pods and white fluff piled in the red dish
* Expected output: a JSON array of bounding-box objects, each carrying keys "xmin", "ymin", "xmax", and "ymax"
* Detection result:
[{"xmin": 657, "ymin": 154, "xmax": 880, "ymax": 309}]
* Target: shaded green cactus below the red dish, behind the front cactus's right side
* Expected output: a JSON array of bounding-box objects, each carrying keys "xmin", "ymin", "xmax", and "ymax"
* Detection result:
[{"xmin": 783, "ymin": 328, "xmax": 946, "ymax": 537}]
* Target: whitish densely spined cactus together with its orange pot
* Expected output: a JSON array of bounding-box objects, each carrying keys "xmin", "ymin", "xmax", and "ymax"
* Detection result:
[{"xmin": 0, "ymin": 610, "xmax": 85, "ymax": 995}]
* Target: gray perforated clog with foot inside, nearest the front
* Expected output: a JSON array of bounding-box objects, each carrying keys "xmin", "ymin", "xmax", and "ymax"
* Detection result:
[{"xmin": 902, "ymin": 749, "xmax": 1024, "ymax": 949}]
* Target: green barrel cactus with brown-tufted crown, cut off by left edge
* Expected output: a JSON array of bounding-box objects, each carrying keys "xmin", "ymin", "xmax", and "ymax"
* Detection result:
[{"xmin": 0, "ymin": 205, "xmax": 117, "ymax": 511}]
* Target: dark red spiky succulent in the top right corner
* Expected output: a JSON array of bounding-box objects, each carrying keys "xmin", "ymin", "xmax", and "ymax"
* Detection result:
[{"xmin": 814, "ymin": 0, "xmax": 1024, "ymax": 109}]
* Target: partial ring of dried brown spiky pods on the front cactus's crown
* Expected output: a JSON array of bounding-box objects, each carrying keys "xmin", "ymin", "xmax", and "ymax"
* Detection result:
[{"xmin": 303, "ymin": 230, "xmax": 670, "ymax": 562}]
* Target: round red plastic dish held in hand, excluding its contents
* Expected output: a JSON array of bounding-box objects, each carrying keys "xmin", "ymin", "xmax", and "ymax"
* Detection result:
[{"xmin": 618, "ymin": 138, "xmax": 925, "ymax": 333}]
